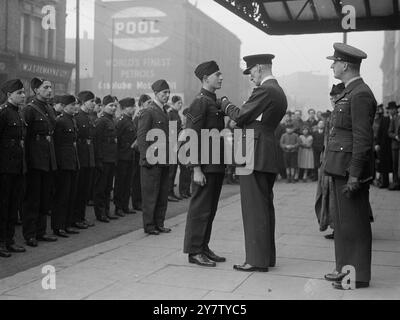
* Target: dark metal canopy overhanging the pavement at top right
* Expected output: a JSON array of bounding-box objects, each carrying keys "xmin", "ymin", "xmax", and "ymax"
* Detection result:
[{"xmin": 214, "ymin": 0, "xmax": 400, "ymax": 35}]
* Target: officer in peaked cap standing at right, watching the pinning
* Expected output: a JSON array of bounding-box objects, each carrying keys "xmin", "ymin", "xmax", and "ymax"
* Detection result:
[{"xmin": 323, "ymin": 43, "xmax": 377, "ymax": 289}]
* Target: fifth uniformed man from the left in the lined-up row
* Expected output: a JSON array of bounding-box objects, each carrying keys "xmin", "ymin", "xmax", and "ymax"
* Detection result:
[{"xmin": 94, "ymin": 95, "xmax": 118, "ymax": 222}]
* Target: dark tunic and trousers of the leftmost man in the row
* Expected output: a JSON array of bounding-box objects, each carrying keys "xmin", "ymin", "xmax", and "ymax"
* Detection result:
[{"xmin": 0, "ymin": 102, "xmax": 26, "ymax": 245}]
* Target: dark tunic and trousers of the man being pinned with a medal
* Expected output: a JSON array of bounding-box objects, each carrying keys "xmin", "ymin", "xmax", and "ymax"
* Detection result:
[{"xmin": 183, "ymin": 89, "xmax": 225, "ymax": 254}]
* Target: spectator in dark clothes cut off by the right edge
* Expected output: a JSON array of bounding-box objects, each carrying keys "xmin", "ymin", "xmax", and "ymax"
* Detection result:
[{"xmin": 387, "ymin": 101, "xmax": 400, "ymax": 191}]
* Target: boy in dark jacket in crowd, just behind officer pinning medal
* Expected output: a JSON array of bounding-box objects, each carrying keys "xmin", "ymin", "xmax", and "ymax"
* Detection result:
[{"xmin": 280, "ymin": 124, "xmax": 299, "ymax": 183}]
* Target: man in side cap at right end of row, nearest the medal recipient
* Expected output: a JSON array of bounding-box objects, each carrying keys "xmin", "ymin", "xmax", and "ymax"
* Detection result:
[{"xmin": 137, "ymin": 80, "xmax": 171, "ymax": 235}]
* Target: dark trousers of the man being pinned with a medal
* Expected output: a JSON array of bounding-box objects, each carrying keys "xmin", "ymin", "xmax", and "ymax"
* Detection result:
[{"xmin": 183, "ymin": 173, "xmax": 225, "ymax": 254}]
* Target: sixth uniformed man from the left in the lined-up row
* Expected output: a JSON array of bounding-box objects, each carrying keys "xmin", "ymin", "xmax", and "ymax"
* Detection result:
[{"xmin": 114, "ymin": 98, "xmax": 136, "ymax": 217}]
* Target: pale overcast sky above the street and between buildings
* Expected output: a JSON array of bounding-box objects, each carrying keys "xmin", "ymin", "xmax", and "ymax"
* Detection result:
[{"xmin": 67, "ymin": 0, "xmax": 383, "ymax": 102}]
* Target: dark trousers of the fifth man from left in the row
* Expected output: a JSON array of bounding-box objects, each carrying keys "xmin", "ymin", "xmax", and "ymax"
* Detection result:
[{"xmin": 94, "ymin": 162, "xmax": 115, "ymax": 218}]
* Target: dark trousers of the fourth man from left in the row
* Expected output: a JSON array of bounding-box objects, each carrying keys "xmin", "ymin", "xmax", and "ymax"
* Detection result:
[{"xmin": 73, "ymin": 167, "xmax": 94, "ymax": 222}]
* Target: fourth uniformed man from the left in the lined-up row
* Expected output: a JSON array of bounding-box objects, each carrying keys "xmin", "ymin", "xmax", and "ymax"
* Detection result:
[{"xmin": 73, "ymin": 91, "xmax": 97, "ymax": 229}]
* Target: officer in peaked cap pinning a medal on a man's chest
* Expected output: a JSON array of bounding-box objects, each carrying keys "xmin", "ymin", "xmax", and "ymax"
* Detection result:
[{"xmin": 222, "ymin": 54, "xmax": 287, "ymax": 272}]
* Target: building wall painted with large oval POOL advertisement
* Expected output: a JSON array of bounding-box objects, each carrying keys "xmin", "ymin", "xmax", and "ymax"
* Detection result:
[{"xmin": 93, "ymin": 0, "xmax": 184, "ymax": 98}]
